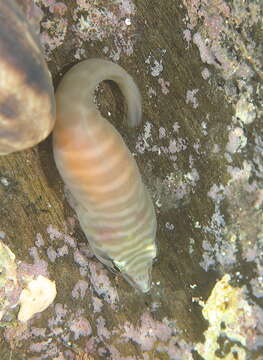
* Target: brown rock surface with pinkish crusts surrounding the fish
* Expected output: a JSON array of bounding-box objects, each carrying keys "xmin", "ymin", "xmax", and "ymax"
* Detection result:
[{"xmin": 0, "ymin": 0, "xmax": 263, "ymax": 360}]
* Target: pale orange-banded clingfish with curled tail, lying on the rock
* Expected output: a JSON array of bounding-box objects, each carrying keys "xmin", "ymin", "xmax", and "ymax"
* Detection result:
[{"xmin": 53, "ymin": 59, "xmax": 157, "ymax": 292}]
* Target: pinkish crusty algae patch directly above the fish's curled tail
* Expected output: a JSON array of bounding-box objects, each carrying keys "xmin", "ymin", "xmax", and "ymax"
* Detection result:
[{"xmin": 33, "ymin": 0, "xmax": 136, "ymax": 61}]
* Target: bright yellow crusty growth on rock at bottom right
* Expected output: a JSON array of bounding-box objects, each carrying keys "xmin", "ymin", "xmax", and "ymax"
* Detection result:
[{"xmin": 196, "ymin": 274, "xmax": 253, "ymax": 360}]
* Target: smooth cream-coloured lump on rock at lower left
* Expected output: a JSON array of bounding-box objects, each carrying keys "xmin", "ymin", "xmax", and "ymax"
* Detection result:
[{"xmin": 18, "ymin": 275, "xmax": 57, "ymax": 322}]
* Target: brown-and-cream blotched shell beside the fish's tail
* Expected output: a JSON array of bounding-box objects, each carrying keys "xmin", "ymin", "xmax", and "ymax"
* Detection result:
[{"xmin": 0, "ymin": 0, "xmax": 55, "ymax": 155}]
